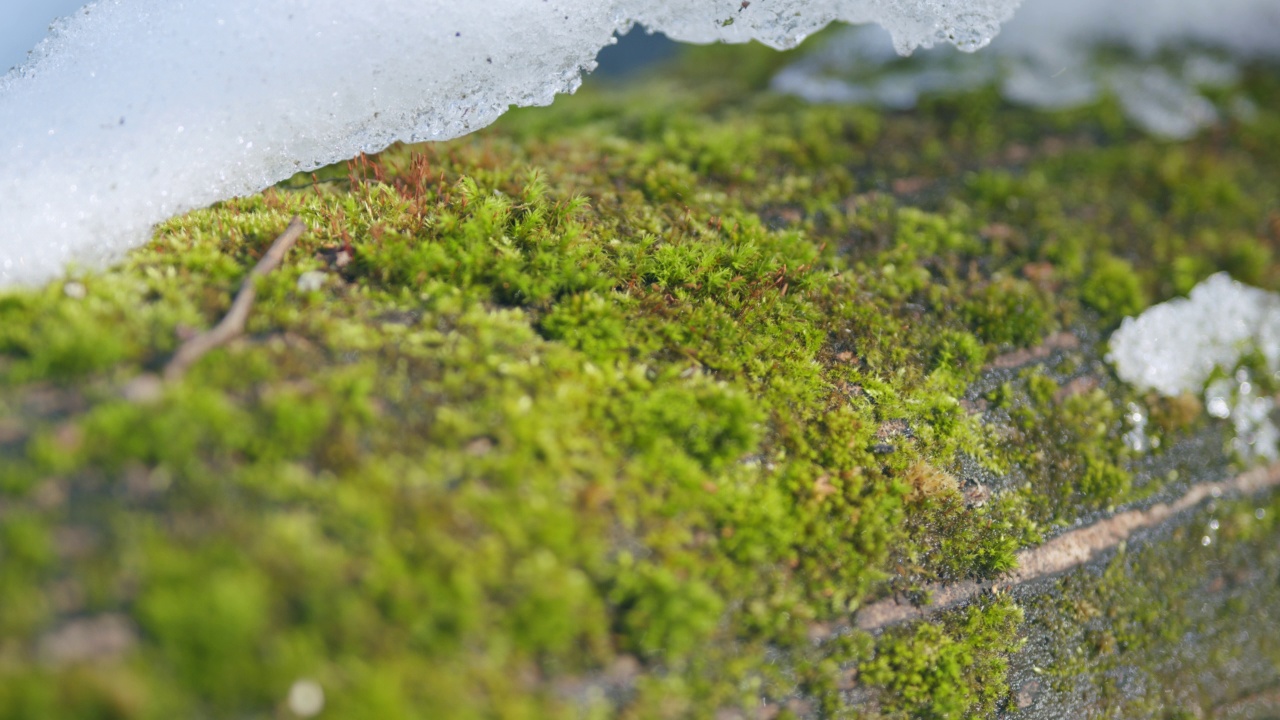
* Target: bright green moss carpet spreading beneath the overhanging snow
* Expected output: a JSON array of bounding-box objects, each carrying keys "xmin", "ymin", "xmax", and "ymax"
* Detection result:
[{"xmin": 0, "ymin": 37, "xmax": 1280, "ymax": 719}]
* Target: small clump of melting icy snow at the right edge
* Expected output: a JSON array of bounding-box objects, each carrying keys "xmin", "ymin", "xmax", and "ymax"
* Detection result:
[{"xmin": 1107, "ymin": 273, "xmax": 1280, "ymax": 459}]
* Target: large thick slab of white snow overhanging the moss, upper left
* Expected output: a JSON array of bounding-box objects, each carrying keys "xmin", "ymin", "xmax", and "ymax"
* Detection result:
[{"xmin": 0, "ymin": 0, "xmax": 1018, "ymax": 284}]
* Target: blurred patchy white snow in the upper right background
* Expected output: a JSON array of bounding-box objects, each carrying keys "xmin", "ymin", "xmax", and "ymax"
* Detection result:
[{"xmin": 774, "ymin": 0, "xmax": 1280, "ymax": 138}]
